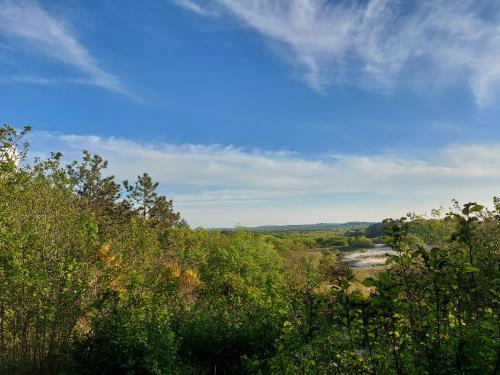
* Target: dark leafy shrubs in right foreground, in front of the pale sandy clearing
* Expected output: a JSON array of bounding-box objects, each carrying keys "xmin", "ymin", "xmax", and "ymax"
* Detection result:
[{"xmin": 271, "ymin": 203, "xmax": 500, "ymax": 374}]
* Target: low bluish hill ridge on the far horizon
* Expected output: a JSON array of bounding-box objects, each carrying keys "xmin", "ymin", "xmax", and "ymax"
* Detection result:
[{"xmin": 212, "ymin": 221, "xmax": 374, "ymax": 232}]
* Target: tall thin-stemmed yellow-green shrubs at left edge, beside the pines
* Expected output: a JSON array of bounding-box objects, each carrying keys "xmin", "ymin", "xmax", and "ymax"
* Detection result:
[{"xmin": 0, "ymin": 146, "xmax": 103, "ymax": 372}]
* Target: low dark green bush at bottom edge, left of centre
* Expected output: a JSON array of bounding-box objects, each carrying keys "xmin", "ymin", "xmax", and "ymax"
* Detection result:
[{"xmin": 65, "ymin": 292, "xmax": 181, "ymax": 375}]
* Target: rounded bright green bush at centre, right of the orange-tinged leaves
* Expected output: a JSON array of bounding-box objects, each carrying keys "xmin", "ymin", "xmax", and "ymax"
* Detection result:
[{"xmin": 180, "ymin": 232, "xmax": 289, "ymax": 372}]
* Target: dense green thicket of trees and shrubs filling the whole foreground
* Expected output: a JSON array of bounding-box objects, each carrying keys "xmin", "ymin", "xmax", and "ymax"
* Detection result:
[{"xmin": 0, "ymin": 127, "xmax": 500, "ymax": 374}]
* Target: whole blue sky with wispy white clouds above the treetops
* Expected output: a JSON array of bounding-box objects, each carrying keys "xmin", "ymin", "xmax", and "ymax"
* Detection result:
[{"xmin": 0, "ymin": 0, "xmax": 500, "ymax": 226}]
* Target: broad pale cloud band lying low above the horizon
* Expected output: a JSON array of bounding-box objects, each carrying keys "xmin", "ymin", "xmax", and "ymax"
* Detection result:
[{"xmin": 32, "ymin": 132, "xmax": 500, "ymax": 225}]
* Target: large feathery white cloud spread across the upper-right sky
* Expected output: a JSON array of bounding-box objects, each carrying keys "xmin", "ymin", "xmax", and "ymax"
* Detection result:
[{"xmin": 176, "ymin": 0, "xmax": 500, "ymax": 107}]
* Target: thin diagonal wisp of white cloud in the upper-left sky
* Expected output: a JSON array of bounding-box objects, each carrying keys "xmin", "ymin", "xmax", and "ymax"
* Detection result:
[{"xmin": 0, "ymin": 0, "xmax": 133, "ymax": 96}]
